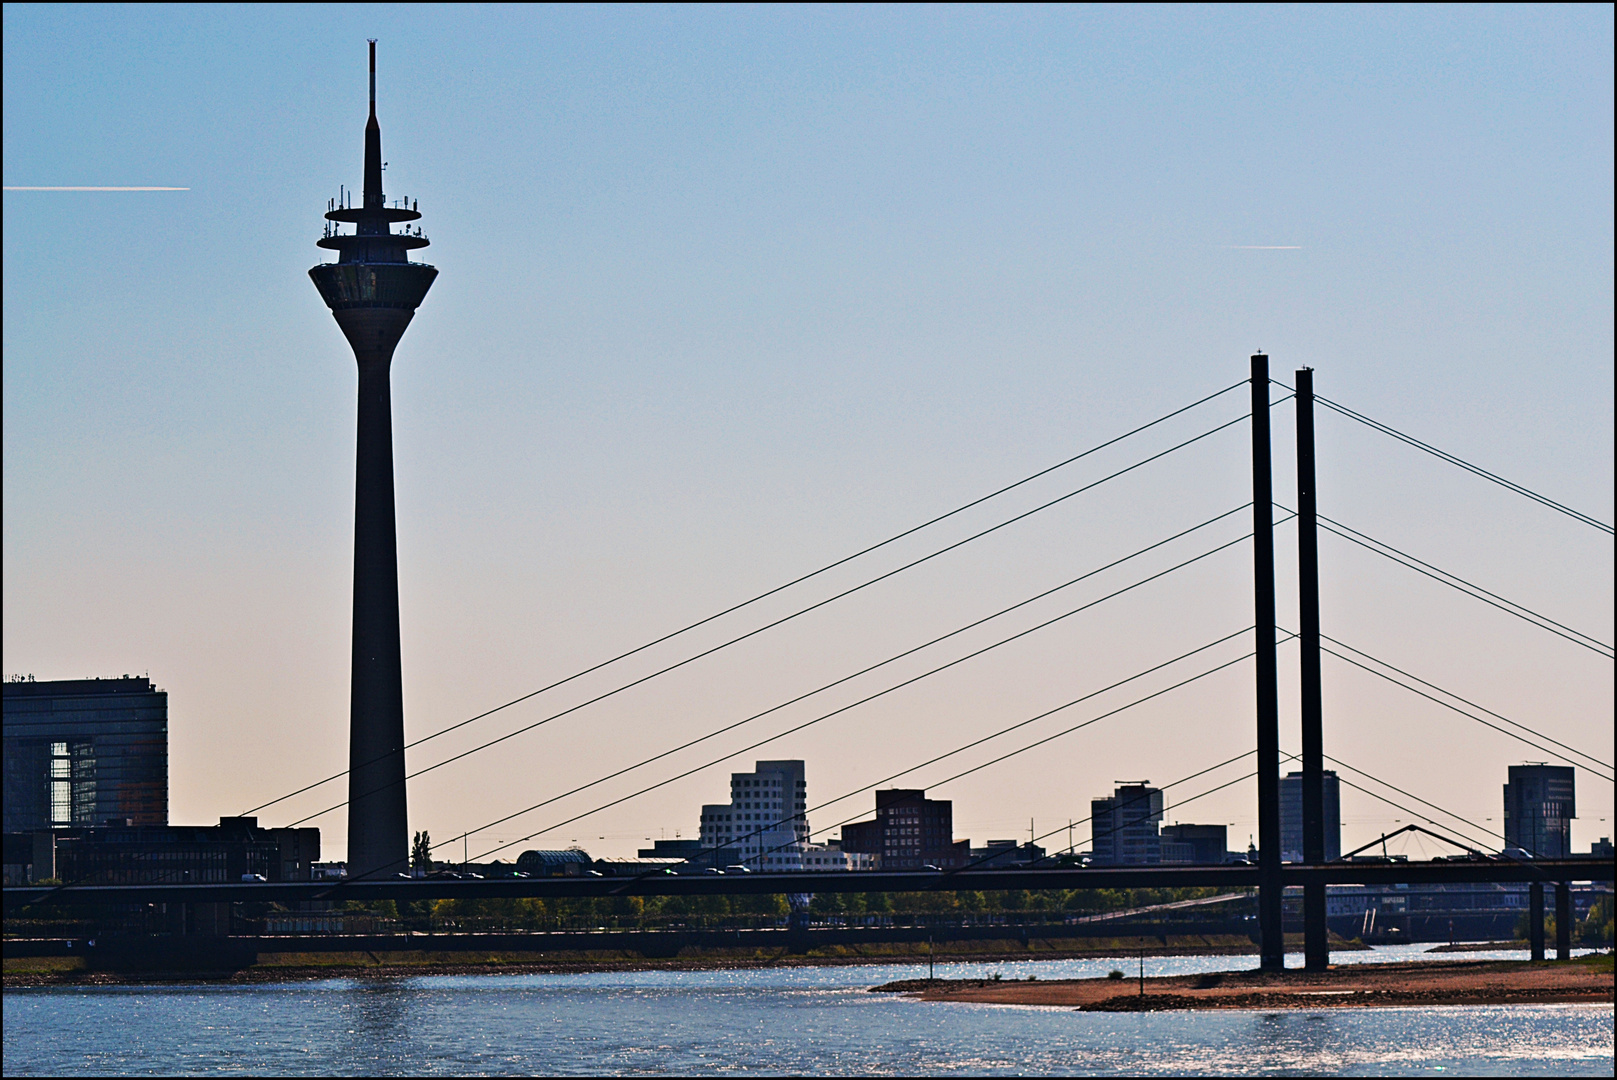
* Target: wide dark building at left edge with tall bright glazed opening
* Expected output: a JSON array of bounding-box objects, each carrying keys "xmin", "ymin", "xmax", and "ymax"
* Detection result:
[{"xmin": 5, "ymin": 676, "xmax": 168, "ymax": 833}]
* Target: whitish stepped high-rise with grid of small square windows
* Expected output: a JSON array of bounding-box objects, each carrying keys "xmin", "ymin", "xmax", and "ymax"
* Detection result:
[{"xmin": 700, "ymin": 761, "xmax": 809, "ymax": 870}]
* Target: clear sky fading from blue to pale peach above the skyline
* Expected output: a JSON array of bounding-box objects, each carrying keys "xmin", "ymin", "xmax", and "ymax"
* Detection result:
[{"xmin": 3, "ymin": 5, "xmax": 1614, "ymax": 857}]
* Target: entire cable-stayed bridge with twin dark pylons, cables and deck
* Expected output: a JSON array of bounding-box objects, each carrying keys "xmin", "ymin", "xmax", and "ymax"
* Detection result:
[{"xmin": 5, "ymin": 354, "xmax": 1614, "ymax": 967}]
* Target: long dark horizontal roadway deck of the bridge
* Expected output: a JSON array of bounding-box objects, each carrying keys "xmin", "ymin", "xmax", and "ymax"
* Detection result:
[{"xmin": 3, "ymin": 857, "xmax": 1614, "ymax": 912}]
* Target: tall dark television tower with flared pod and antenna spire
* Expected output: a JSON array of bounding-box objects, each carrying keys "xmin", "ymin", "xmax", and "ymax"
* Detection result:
[{"xmin": 309, "ymin": 40, "xmax": 438, "ymax": 880}]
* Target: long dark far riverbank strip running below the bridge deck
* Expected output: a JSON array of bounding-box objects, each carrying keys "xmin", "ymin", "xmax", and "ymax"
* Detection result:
[{"xmin": 3, "ymin": 934, "xmax": 1366, "ymax": 988}]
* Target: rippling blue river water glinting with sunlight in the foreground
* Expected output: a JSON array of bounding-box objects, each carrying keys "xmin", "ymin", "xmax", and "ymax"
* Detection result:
[{"xmin": 5, "ymin": 946, "xmax": 1612, "ymax": 1075}]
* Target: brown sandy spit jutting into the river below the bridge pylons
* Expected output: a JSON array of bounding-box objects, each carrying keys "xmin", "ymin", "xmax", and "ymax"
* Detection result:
[{"xmin": 872, "ymin": 952, "xmax": 1614, "ymax": 1012}]
